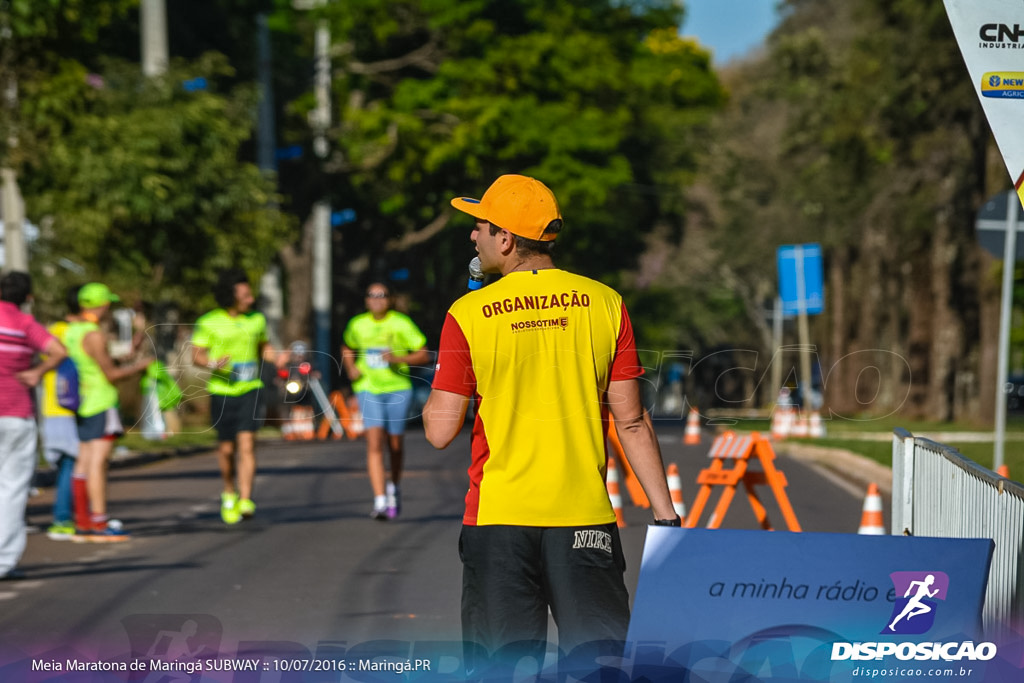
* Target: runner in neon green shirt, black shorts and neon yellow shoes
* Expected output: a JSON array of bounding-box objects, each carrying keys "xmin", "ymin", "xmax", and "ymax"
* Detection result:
[{"xmin": 191, "ymin": 269, "xmax": 285, "ymax": 524}]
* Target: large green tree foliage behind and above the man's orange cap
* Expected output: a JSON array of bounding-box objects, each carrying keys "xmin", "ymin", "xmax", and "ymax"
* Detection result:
[{"xmin": 279, "ymin": 0, "xmax": 723, "ymax": 319}]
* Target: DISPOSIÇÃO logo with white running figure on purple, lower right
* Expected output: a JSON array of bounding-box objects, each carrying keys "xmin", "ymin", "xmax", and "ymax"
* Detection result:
[{"xmin": 831, "ymin": 571, "xmax": 996, "ymax": 661}]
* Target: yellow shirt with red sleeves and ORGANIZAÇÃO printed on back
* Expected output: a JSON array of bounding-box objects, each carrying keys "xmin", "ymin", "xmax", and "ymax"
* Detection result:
[{"xmin": 433, "ymin": 269, "xmax": 643, "ymax": 526}]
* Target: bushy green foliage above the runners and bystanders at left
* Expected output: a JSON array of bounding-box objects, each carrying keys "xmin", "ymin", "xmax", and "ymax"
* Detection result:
[{"xmin": 22, "ymin": 54, "xmax": 290, "ymax": 307}]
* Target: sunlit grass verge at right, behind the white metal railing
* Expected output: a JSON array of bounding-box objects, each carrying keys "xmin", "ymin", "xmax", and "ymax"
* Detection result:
[{"xmin": 708, "ymin": 415, "xmax": 1024, "ymax": 480}]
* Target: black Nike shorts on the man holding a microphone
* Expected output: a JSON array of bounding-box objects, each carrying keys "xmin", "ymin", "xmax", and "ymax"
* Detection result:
[{"xmin": 459, "ymin": 522, "xmax": 630, "ymax": 666}]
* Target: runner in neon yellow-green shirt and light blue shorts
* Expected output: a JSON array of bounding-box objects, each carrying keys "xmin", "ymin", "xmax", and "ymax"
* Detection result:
[{"xmin": 341, "ymin": 283, "xmax": 430, "ymax": 520}]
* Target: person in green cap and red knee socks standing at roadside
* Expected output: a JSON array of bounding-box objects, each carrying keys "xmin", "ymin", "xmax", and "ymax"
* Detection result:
[{"xmin": 65, "ymin": 283, "xmax": 153, "ymax": 543}]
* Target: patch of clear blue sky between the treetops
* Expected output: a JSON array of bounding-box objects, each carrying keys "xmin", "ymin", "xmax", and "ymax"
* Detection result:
[{"xmin": 680, "ymin": 0, "xmax": 777, "ymax": 66}]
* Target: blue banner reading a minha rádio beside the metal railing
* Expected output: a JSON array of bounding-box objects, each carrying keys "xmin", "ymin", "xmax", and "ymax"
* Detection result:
[{"xmin": 629, "ymin": 527, "xmax": 1024, "ymax": 683}]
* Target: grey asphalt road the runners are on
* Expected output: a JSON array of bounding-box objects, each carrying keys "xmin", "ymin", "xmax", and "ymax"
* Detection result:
[{"xmin": 0, "ymin": 425, "xmax": 862, "ymax": 681}]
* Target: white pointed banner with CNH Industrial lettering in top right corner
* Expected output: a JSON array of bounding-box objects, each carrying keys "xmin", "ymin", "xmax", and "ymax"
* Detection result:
[{"xmin": 944, "ymin": 0, "xmax": 1024, "ymax": 204}]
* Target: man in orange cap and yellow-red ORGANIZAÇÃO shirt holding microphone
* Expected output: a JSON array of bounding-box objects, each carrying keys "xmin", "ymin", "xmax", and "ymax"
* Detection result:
[{"xmin": 423, "ymin": 175, "xmax": 679, "ymax": 668}]
